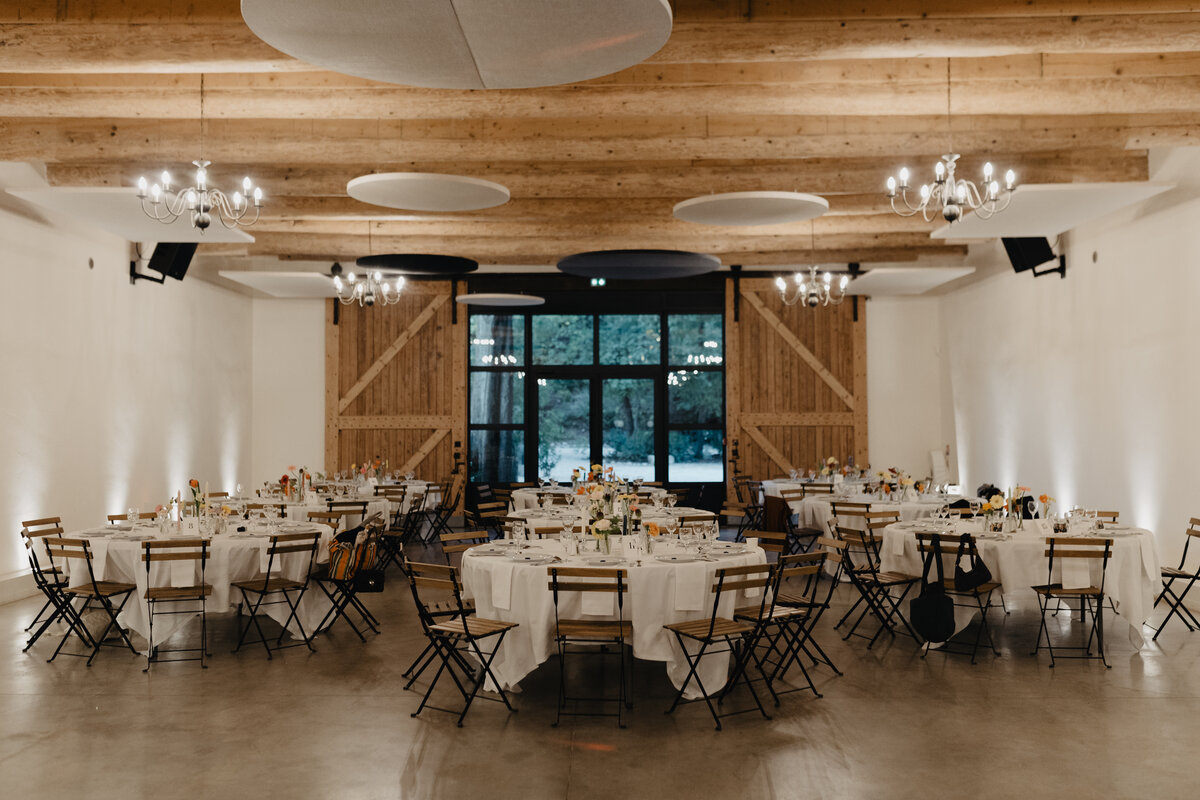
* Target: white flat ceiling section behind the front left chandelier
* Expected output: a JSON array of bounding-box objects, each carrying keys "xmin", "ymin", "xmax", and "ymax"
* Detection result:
[{"xmin": 8, "ymin": 186, "xmax": 254, "ymax": 243}]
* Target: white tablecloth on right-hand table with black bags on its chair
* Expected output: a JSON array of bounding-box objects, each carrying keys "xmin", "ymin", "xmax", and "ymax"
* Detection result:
[{"xmin": 881, "ymin": 519, "xmax": 1162, "ymax": 648}]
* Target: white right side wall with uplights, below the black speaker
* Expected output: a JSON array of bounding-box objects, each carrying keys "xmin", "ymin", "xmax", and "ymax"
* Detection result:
[{"xmin": 943, "ymin": 166, "xmax": 1200, "ymax": 560}]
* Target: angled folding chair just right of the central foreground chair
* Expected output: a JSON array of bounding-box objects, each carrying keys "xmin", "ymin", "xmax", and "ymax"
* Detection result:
[{"xmin": 662, "ymin": 564, "xmax": 772, "ymax": 730}]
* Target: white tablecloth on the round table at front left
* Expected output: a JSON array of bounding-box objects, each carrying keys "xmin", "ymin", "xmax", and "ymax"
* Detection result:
[{"xmin": 64, "ymin": 521, "xmax": 332, "ymax": 644}]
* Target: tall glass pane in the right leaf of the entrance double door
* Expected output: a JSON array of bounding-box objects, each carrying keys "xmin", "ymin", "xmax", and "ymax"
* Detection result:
[{"xmin": 602, "ymin": 378, "xmax": 654, "ymax": 481}]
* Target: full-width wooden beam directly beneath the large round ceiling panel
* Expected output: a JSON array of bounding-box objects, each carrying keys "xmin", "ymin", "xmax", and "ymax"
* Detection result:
[{"xmin": 11, "ymin": 74, "xmax": 1200, "ymax": 118}]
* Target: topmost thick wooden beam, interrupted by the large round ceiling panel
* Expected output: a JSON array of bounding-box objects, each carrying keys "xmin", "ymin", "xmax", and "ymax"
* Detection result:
[{"xmin": 7, "ymin": 12, "xmax": 1200, "ymax": 72}]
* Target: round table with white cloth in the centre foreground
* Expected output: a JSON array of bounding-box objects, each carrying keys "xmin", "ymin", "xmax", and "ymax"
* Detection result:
[{"xmin": 462, "ymin": 536, "xmax": 767, "ymax": 698}]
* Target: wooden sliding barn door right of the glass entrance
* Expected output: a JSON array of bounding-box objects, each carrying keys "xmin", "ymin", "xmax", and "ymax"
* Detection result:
[{"xmin": 725, "ymin": 278, "xmax": 869, "ymax": 489}]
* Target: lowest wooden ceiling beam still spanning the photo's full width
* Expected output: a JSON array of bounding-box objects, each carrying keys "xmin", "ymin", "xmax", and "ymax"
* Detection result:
[{"xmin": 0, "ymin": 115, "xmax": 1180, "ymax": 163}]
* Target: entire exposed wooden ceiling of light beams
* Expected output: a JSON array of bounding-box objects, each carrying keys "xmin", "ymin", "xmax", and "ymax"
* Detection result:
[{"xmin": 0, "ymin": 0, "xmax": 1200, "ymax": 269}]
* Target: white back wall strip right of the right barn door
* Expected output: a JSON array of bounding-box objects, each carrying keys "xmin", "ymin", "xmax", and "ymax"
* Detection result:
[{"xmin": 866, "ymin": 297, "xmax": 954, "ymax": 477}]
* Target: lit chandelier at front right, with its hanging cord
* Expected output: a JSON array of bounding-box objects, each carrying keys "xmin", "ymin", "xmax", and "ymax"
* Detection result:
[{"xmin": 888, "ymin": 59, "xmax": 1016, "ymax": 223}]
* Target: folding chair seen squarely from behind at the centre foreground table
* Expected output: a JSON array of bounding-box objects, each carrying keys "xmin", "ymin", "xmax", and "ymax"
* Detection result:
[{"xmin": 548, "ymin": 566, "xmax": 634, "ymax": 728}]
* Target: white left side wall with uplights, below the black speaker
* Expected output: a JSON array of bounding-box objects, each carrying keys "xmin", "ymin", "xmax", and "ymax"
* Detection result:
[{"xmin": 0, "ymin": 198, "xmax": 251, "ymax": 594}]
